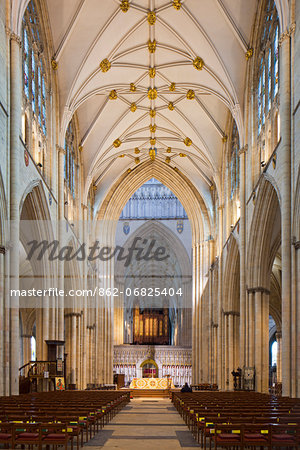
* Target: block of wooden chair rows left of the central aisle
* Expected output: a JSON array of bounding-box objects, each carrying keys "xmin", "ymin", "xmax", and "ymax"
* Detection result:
[{"xmin": 0, "ymin": 391, "xmax": 130, "ymax": 450}]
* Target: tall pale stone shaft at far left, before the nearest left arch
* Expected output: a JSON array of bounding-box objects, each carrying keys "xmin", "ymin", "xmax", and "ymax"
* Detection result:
[{"xmin": 10, "ymin": 33, "xmax": 22, "ymax": 395}]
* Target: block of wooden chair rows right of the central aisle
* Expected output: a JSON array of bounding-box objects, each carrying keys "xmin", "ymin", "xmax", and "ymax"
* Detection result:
[{"xmin": 172, "ymin": 392, "xmax": 300, "ymax": 448}]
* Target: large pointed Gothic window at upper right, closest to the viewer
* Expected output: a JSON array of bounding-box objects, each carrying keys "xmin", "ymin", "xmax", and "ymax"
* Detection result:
[{"xmin": 257, "ymin": 0, "xmax": 279, "ymax": 141}]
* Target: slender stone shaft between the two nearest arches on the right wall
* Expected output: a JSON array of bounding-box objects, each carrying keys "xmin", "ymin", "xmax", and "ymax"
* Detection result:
[{"xmin": 239, "ymin": 146, "xmax": 247, "ymax": 368}]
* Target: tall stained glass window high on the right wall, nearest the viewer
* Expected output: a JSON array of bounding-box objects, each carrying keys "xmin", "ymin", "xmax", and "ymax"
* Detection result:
[{"xmin": 257, "ymin": 0, "xmax": 279, "ymax": 135}]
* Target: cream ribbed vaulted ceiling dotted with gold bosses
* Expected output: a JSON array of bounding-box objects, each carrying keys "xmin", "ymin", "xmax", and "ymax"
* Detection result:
[{"xmin": 47, "ymin": 0, "xmax": 257, "ymax": 211}]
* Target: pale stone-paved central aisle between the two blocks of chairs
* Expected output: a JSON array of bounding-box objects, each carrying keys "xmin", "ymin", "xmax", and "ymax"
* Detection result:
[{"xmin": 85, "ymin": 398, "xmax": 199, "ymax": 450}]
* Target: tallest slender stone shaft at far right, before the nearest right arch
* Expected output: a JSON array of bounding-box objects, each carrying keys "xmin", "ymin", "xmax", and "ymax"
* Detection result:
[{"xmin": 279, "ymin": 30, "xmax": 292, "ymax": 396}]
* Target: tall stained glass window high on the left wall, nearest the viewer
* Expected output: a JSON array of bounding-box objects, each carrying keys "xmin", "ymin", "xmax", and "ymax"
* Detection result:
[{"xmin": 23, "ymin": 0, "xmax": 47, "ymax": 136}]
